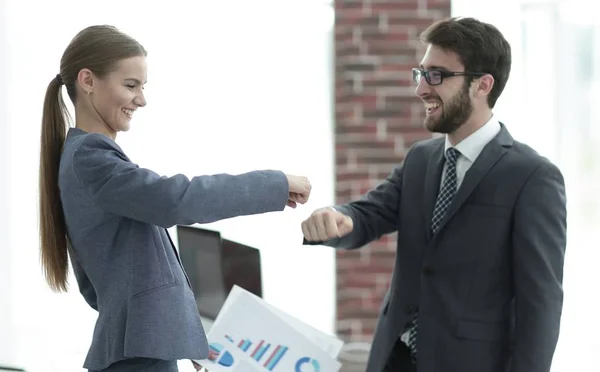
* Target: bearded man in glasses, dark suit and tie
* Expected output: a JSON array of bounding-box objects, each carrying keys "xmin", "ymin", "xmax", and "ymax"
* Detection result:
[{"xmin": 302, "ymin": 18, "xmax": 566, "ymax": 372}]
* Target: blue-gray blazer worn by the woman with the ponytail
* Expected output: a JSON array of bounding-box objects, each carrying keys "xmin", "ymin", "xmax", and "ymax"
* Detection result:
[{"xmin": 59, "ymin": 128, "xmax": 289, "ymax": 370}]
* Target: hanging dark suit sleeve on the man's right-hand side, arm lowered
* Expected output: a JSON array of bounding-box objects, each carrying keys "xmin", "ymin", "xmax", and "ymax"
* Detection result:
[{"xmin": 510, "ymin": 162, "xmax": 567, "ymax": 372}]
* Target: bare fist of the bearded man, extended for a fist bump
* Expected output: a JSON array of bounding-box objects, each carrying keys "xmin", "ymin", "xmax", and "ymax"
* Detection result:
[{"xmin": 302, "ymin": 207, "xmax": 354, "ymax": 242}]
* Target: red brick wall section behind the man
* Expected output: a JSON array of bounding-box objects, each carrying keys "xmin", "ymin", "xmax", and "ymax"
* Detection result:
[{"xmin": 335, "ymin": 0, "xmax": 450, "ymax": 348}]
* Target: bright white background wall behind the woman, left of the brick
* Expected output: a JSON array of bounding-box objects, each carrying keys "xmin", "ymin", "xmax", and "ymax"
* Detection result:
[{"xmin": 0, "ymin": 0, "xmax": 335, "ymax": 372}]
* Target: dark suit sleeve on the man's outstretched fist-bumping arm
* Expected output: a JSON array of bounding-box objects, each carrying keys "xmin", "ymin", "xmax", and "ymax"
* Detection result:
[{"xmin": 303, "ymin": 165, "xmax": 403, "ymax": 249}]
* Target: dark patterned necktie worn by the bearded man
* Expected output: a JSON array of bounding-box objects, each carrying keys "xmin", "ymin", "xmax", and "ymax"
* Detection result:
[{"xmin": 408, "ymin": 147, "xmax": 460, "ymax": 360}]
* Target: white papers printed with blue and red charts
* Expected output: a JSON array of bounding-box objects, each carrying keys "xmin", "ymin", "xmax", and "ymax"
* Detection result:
[{"xmin": 196, "ymin": 286, "xmax": 343, "ymax": 372}]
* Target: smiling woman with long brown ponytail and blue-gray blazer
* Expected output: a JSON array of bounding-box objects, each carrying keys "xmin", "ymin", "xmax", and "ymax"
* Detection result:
[{"xmin": 40, "ymin": 26, "xmax": 311, "ymax": 372}]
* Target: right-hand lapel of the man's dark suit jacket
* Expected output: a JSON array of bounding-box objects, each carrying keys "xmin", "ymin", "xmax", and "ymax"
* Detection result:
[{"xmin": 429, "ymin": 123, "xmax": 513, "ymax": 232}]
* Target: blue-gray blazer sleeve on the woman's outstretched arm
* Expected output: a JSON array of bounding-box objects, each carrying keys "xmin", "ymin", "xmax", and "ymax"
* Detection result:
[{"xmin": 73, "ymin": 134, "xmax": 289, "ymax": 228}]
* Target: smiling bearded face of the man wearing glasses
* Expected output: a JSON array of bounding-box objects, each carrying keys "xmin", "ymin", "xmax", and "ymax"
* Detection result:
[{"xmin": 415, "ymin": 44, "xmax": 473, "ymax": 133}]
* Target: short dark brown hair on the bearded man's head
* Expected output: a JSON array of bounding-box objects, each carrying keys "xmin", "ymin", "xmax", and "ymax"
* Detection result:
[{"xmin": 421, "ymin": 17, "xmax": 511, "ymax": 108}]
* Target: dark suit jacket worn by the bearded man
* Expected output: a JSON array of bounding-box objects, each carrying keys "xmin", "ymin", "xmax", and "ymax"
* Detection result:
[{"xmin": 312, "ymin": 125, "xmax": 566, "ymax": 372}]
